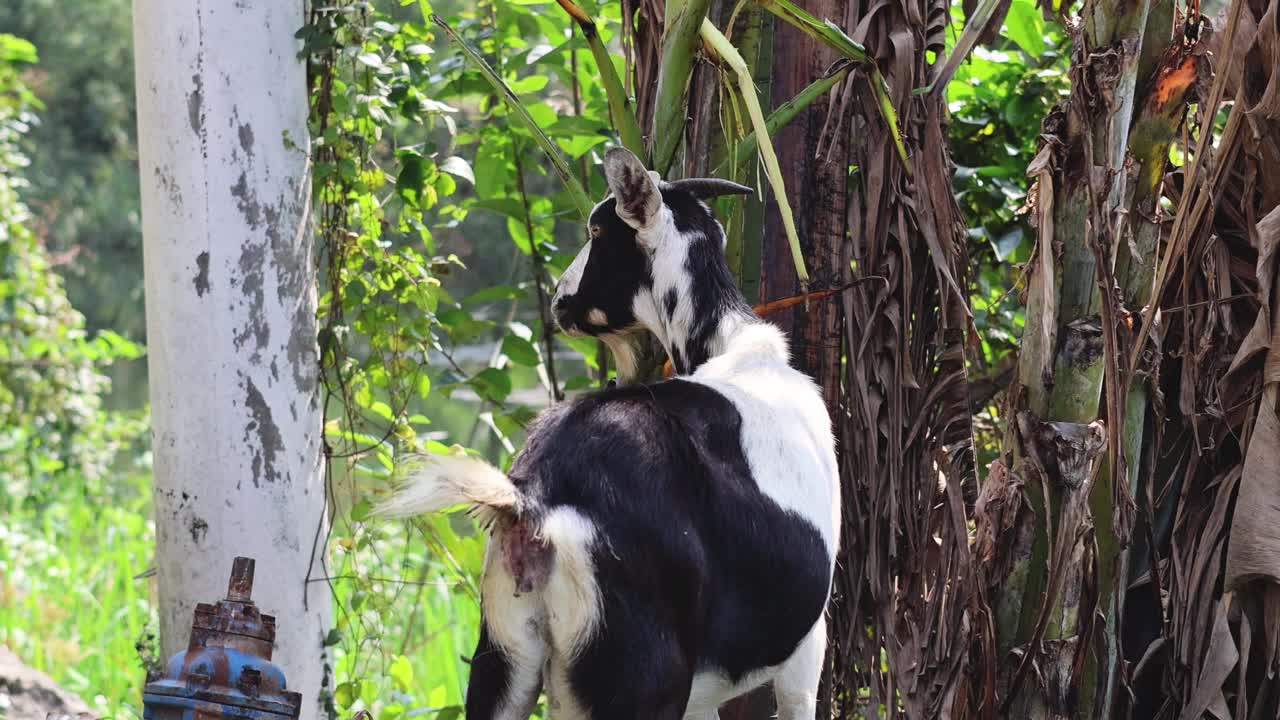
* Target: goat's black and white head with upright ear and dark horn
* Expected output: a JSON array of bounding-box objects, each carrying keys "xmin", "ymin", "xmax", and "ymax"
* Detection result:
[{"xmin": 553, "ymin": 147, "xmax": 751, "ymax": 365}]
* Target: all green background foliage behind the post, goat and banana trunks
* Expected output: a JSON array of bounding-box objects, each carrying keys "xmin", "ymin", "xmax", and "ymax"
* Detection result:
[{"xmin": 0, "ymin": 0, "xmax": 1069, "ymax": 720}]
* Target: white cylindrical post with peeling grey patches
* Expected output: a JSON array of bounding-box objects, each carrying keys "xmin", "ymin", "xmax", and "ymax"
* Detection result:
[{"xmin": 133, "ymin": 0, "xmax": 330, "ymax": 719}]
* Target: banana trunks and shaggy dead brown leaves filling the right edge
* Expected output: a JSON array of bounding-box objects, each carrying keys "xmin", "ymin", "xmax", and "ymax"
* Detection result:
[{"xmin": 978, "ymin": 1, "xmax": 1280, "ymax": 717}]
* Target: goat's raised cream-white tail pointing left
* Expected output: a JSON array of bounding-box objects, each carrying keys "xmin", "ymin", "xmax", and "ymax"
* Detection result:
[{"xmin": 372, "ymin": 452, "xmax": 525, "ymax": 525}]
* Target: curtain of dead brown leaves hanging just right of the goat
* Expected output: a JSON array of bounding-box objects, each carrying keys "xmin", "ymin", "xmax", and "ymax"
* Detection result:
[{"xmin": 826, "ymin": 0, "xmax": 995, "ymax": 717}]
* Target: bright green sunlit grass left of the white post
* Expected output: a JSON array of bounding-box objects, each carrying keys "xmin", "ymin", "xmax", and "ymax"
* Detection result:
[{"xmin": 0, "ymin": 466, "xmax": 156, "ymax": 717}]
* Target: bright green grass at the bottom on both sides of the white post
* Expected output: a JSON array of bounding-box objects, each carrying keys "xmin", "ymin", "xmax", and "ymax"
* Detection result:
[{"xmin": 0, "ymin": 458, "xmax": 494, "ymax": 720}]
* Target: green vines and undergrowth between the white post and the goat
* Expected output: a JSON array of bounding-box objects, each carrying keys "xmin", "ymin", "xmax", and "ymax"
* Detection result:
[{"xmin": 298, "ymin": 0, "xmax": 617, "ymax": 720}]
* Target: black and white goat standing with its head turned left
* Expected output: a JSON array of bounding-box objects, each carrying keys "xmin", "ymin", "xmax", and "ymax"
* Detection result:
[{"xmin": 375, "ymin": 150, "xmax": 840, "ymax": 720}]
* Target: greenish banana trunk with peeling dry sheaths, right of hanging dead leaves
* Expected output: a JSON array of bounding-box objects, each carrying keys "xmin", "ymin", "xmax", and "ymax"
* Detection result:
[{"xmin": 979, "ymin": 0, "xmax": 1194, "ymax": 717}]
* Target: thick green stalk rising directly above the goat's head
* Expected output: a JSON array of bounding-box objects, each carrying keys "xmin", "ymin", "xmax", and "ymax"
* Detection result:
[{"xmin": 650, "ymin": 0, "xmax": 710, "ymax": 177}]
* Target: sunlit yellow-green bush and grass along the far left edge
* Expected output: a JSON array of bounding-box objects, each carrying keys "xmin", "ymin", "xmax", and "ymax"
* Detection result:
[{"xmin": 0, "ymin": 33, "xmax": 154, "ymax": 715}]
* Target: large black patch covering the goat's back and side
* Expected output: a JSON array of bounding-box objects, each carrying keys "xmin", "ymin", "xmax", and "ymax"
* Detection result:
[{"xmin": 509, "ymin": 379, "xmax": 832, "ymax": 684}]
